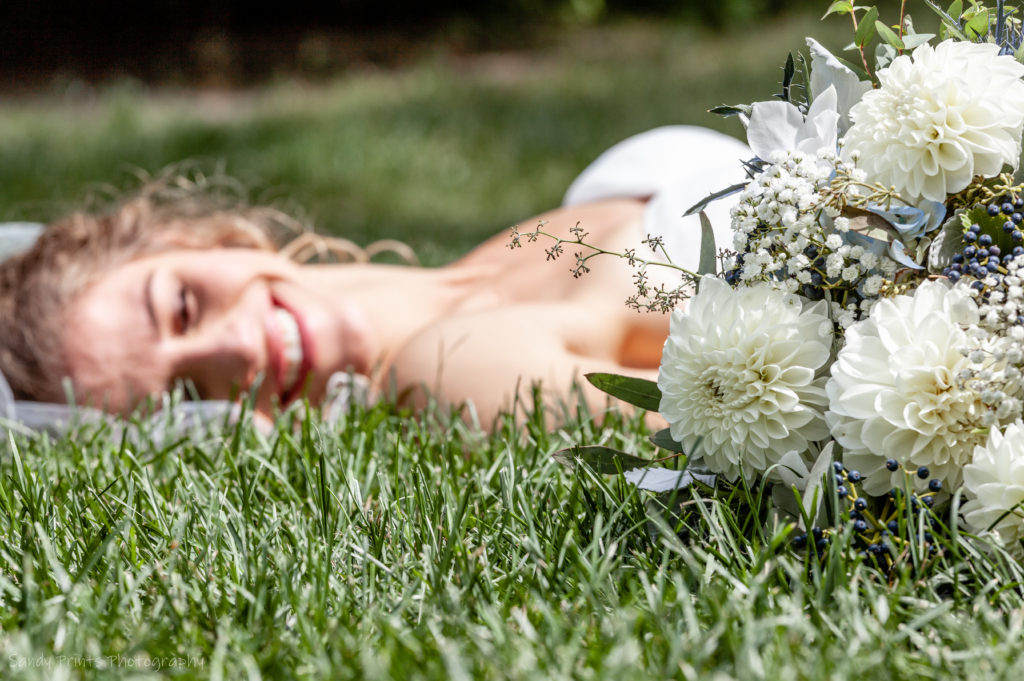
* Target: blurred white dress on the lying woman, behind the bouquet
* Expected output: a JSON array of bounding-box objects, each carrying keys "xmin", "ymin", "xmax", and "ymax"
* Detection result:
[{"xmin": 562, "ymin": 125, "xmax": 754, "ymax": 271}]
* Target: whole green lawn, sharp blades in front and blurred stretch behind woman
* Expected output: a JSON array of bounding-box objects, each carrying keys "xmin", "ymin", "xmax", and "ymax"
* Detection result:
[{"xmin": 0, "ymin": 10, "xmax": 1024, "ymax": 681}]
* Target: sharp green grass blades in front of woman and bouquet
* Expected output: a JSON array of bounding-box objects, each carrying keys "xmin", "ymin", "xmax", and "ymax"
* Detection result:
[{"xmin": 0, "ymin": 395, "xmax": 1024, "ymax": 679}]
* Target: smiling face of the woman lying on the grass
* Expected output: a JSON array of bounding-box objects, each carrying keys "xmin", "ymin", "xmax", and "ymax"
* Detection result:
[{"xmin": 63, "ymin": 249, "xmax": 371, "ymax": 413}]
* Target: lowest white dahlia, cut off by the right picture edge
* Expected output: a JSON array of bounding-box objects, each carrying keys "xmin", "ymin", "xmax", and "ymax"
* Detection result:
[{"xmin": 963, "ymin": 421, "xmax": 1024, "ymax": 544}]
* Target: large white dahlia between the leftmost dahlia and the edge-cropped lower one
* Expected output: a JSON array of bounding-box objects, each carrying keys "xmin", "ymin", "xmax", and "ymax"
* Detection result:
[{"xmin": 825, "ymin": 282, "xmax": 985, "ymax": 495}]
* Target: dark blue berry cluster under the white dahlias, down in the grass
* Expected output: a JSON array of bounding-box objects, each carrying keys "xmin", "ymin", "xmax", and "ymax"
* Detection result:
[{"xmin": 793, "ymin": 459, "xmax": 942, "ymax": 572}]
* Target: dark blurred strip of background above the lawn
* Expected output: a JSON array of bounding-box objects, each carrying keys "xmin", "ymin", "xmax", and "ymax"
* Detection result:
[{"xmin": 0, "ymin": 0, "xmax": 826, "ymax": 87}]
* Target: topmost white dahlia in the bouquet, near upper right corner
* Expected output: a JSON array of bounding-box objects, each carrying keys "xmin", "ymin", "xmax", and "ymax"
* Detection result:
[{"xmin": 843, "ymin": 40, "xmax": 1024, "ymax": 202}]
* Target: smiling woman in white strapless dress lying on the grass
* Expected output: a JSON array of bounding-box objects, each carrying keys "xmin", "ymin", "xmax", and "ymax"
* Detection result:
[{"xmin": 0, "ymin": 128, "xmax": 745, "ymax": 425}]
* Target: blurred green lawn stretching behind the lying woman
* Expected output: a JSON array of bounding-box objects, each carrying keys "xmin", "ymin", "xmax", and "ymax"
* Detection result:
[{"xmin": 0, "ymin": 15, "xmax": 849, "ymax": 264}]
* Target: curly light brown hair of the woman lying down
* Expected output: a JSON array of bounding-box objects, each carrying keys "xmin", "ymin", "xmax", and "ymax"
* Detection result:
[{"xmin": 0, "ymin": 176, "xmax": 302, "ymax": 401}]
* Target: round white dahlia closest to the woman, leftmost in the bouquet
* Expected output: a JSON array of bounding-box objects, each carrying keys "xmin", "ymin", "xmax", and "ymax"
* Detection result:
[{"xmin": 657, "ymin": 276, "xmax": 831, "ymax": 479}]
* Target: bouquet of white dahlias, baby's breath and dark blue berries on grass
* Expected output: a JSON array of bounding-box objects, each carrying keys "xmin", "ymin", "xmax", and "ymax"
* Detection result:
[{"xmin": 540, "ymin": 2, "xmax": 1024, "ymax": 565}]
